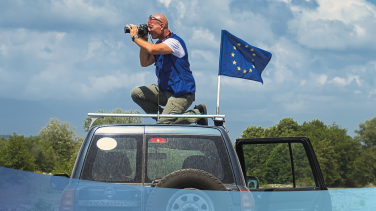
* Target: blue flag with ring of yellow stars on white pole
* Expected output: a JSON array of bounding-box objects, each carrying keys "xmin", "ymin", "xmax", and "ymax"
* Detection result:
[{"xmin": 218, "ymin": 30, "xmax": 272, "ymax": 83}]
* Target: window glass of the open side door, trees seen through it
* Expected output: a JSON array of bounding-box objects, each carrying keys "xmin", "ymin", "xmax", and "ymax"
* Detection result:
[{"xmin": 242, "ymin": 143, "xmax": 315, "ymax": 189}]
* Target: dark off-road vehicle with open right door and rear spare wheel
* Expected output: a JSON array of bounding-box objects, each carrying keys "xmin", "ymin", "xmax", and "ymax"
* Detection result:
[{"xmin": 51, "ymin": 114, "xmax": 331, "ymax": 211}]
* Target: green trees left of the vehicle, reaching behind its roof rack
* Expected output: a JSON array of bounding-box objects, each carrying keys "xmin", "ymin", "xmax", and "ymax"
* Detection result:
[{"xmin": 0, "ymin": 109, "xmax": 142, "ymax": 175}]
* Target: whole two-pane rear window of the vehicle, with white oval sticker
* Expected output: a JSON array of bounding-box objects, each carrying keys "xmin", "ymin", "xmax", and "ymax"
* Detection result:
[{"xmin": 81, "ymin": 133, "xmax": 235, "ymax": 184}]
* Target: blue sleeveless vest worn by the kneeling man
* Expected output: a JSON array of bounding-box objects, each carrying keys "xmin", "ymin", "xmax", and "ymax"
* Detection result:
[{"xmin": 154, "ymin": 34, "xmax": 196, "ymax": 97}]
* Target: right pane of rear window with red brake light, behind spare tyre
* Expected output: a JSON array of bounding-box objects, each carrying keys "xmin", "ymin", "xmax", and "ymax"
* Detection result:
[{"xmin": 147, "ymin": 134, "xmax": 234, "ymax": 183}]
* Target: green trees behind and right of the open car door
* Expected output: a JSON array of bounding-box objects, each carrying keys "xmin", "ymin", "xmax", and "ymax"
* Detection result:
[{"xmin": 241, "ymin": 117, "xmax": 376, "ymax": 187}]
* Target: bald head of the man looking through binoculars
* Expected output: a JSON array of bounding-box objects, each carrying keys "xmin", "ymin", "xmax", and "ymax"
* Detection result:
[{"xmin": 148, "ymin": 14, "xmax": 170, "ymax": 40}]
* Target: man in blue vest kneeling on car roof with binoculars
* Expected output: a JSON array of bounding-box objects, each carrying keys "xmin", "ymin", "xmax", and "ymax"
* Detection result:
[{"xmin": 127, "ymin": 14, "xmax": 208, "ymax": 125}]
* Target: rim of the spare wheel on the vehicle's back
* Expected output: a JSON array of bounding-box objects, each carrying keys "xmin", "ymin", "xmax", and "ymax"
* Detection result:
[{"xmin": 167, "ymin": 190, "xmax": 214, "ymax": 211}]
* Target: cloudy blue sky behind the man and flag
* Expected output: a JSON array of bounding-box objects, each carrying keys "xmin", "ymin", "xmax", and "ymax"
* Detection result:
[{"xmin": 0, "ymin": 0, "xmax": 376, "ymax": 141}]
